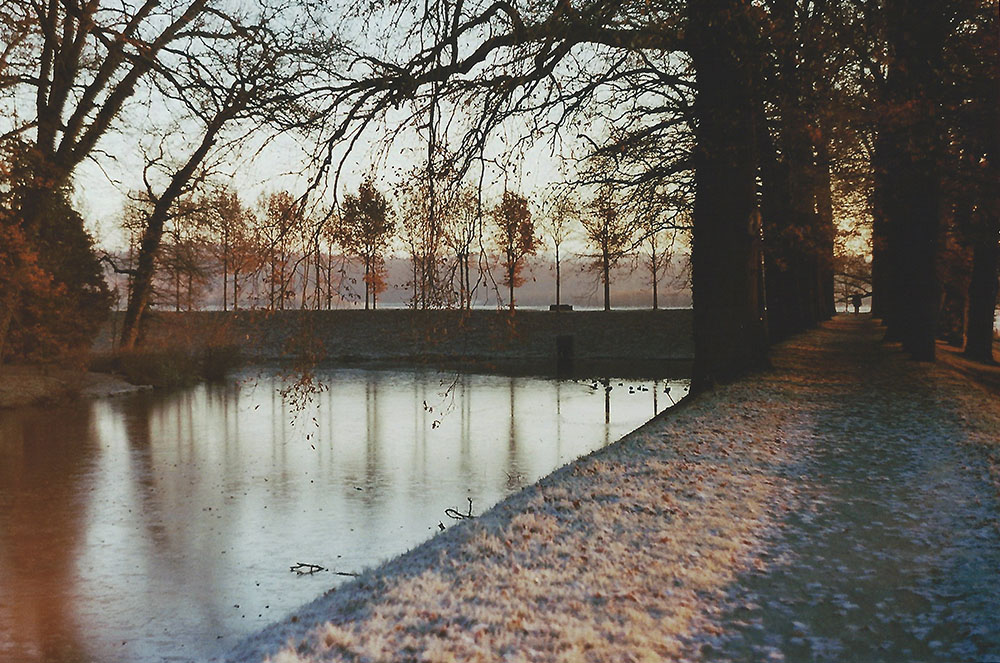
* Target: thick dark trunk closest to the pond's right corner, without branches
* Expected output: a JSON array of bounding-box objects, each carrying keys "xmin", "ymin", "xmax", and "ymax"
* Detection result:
[{"xmin": 688, "ymin": 0, "xmax": 767, "ymax": 390}]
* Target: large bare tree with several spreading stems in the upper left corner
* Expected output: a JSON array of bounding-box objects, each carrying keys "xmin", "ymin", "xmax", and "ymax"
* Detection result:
[{"xmin": 0, "ymin": 0, "xmax": 221, "ymax": 358}]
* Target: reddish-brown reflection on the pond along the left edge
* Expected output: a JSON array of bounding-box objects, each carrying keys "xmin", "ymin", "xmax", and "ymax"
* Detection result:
[{"xmin": 0, "ymin": 404, "xmax": 98, "ymax": 661}]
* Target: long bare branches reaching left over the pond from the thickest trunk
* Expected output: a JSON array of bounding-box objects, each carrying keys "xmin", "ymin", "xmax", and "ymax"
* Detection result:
[{"xmin": 296, "ymin": 2, "xmax": 691, "ymax": 200}]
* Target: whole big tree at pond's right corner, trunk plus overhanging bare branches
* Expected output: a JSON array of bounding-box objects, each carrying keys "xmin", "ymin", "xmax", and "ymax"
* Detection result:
[{"xmin": 292, "ymin": 0, "xmax": 767, "ymax": 388}]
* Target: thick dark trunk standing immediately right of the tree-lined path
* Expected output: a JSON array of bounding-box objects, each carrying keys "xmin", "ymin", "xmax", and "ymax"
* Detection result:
[{"xmin": 875, "ymin": 0, "xmax": 949, "ymax": 361}]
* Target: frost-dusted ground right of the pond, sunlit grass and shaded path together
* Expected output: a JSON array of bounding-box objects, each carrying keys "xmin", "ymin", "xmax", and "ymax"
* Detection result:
[{"xmin": 229, "ymin": 318, "xmax": 1000, "ymax": 663}]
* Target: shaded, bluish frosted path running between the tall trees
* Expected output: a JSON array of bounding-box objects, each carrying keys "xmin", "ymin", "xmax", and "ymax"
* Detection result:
[{"xmin": 701, "ymin": 320, "xmax": 1000, "ymax": 661}]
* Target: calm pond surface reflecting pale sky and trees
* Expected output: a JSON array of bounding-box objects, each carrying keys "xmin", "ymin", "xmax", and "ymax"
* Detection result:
[{"xmin": 0, "ymin": 370, "xmax": 686, "ymax": 663}]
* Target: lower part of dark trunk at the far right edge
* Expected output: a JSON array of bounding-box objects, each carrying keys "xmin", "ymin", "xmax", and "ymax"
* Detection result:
[{"xmin": 964, "ymin": 227, "xmax": 1000, "ymax": 364}]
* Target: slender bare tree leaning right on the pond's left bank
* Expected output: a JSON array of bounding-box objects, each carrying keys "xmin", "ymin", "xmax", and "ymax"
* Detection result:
[{"xmin": 114, "ymin": 3, "xmax": 317, "ymax": 348}]
